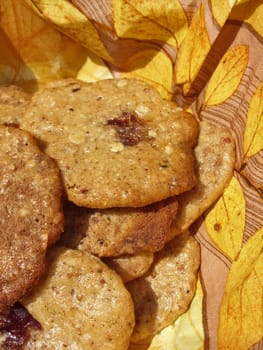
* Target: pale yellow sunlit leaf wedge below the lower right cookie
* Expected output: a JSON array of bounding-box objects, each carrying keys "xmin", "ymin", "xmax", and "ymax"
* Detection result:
[{"xmin": 148, "ymin": 280, "xmax": 204, "ymax": 350}]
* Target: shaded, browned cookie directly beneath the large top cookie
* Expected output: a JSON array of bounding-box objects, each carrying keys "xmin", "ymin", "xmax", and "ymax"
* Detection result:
[{"xmin": 61, "ymin": 198, "xmax": 177, "ymax": 257}]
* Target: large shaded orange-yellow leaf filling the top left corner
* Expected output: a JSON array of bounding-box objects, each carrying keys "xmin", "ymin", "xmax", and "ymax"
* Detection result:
[{"xmin": 0, "ymin": 0, "xmax": 91, "ymax": 84}]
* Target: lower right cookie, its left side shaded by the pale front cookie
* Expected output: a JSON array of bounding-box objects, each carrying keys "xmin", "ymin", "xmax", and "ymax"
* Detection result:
[{"xmin": 126, "ymin": 232, "xmax": 200, "ymax": 344}]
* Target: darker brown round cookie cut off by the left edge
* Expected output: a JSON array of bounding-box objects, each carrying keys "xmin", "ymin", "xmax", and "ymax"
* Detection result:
[{"xmin": 0, "ymin": 126, "xmax": 63, "ymax": 311}]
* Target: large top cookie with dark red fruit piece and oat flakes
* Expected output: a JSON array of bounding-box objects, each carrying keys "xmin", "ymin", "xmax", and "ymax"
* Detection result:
[{"xmin": 22, "ymin": 79, "xmax": 198, "ymax": 208}]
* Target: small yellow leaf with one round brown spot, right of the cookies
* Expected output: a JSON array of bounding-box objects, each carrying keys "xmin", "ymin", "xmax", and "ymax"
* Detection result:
[{"xmin": 205, "ymin": 177, "xmax": 246, "ymax": 260}]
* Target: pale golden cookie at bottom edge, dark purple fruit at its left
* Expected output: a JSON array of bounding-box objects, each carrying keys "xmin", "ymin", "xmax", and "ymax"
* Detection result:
[{"xmin": 22, "ymin": 247, "xmax": 134, "ymax": 350}]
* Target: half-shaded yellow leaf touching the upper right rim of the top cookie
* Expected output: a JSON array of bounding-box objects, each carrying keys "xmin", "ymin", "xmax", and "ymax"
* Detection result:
[{"xmin": 121, "ymin": 50, "xmax": 173, "ymax": 99}]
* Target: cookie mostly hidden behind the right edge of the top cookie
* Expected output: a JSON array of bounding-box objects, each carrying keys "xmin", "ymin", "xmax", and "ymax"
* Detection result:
[{"xmin": 170, "ymin": 121, "xmax": 235, "ymax": 239}]
